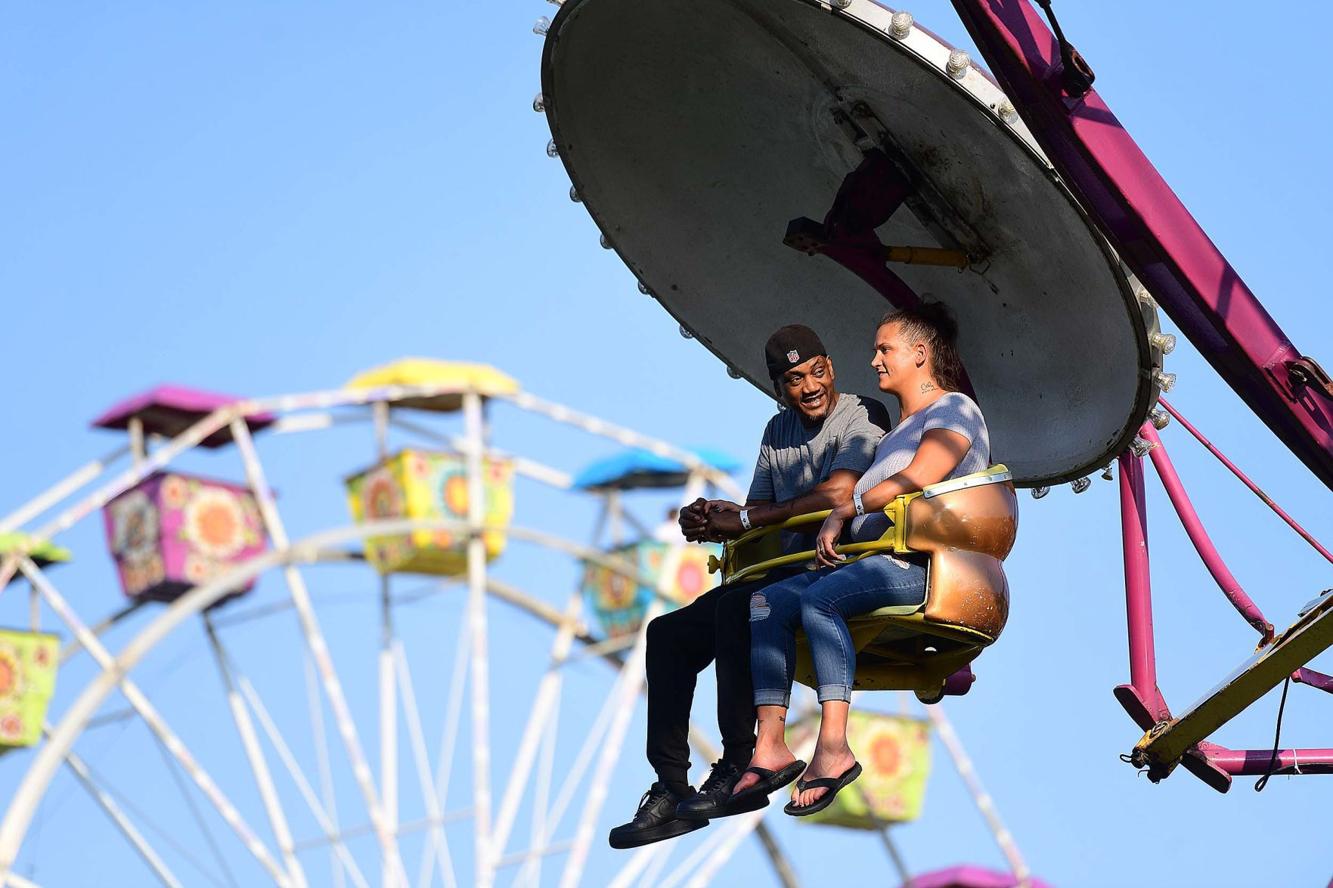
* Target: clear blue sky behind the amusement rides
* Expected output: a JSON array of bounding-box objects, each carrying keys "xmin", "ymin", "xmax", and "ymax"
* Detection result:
[{"xmin": 0, "ymin": 0, "xmax": 1333, "ymax": 885}]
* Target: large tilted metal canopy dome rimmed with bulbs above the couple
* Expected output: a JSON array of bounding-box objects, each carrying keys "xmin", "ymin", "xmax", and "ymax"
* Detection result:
[{"xmin": 541, "ymin": 0, "xmax": 1161, "ymax": 485}]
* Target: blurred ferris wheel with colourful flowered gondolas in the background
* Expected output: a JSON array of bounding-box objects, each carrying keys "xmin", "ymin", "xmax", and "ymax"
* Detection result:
[{"xmin": 0, "ymin": 360, "xmax": 1028, "ymax": 885}]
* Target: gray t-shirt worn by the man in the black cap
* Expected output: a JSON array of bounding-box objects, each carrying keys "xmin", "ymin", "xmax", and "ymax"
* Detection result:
[{"xmin": 748, "ymin": 392, "xmax": 890, "ymax": 503}]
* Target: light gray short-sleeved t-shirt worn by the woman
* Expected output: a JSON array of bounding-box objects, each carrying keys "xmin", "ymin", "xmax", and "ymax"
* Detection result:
[{"xmin": 852, "ymin": 392, "xmax": 990, "ymax": 543}]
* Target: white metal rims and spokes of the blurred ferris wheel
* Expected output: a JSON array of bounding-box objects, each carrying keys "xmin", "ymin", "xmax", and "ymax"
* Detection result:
[{"xmin": 0, "ymin": 376, "xmax": 1029, "ymax": 888}]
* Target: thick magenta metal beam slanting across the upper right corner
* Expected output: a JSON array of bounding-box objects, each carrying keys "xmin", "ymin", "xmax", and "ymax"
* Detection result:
[{"xmin": 953, "ymin": 0, "xmax": 1333, "ymax": 488}]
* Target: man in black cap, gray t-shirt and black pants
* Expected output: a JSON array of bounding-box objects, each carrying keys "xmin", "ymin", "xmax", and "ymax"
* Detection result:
[{"xmin": 611, "ymin": 324, "xmax": 889, "ymax": 848}]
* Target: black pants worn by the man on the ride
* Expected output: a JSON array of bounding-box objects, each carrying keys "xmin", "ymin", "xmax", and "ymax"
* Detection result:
[{"xmin": 645, "ymin": 571, "xmax": 790, "ymax": 785}]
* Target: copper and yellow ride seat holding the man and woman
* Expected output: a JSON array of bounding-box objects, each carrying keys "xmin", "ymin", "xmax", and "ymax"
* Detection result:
[{"xmin": 709, "ymin": 465, "xmax": 1018, "ymax": 703}]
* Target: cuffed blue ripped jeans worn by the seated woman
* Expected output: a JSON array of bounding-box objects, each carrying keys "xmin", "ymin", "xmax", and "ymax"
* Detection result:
[{"xmin": 750, "ymin": 555, "xmax": 926, "ymax": 707}]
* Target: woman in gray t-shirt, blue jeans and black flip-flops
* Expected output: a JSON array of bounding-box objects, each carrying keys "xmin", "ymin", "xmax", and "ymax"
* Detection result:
[{"xmin": 733, "ymin": 304, "xmax": 990, "ymax": 816}]
